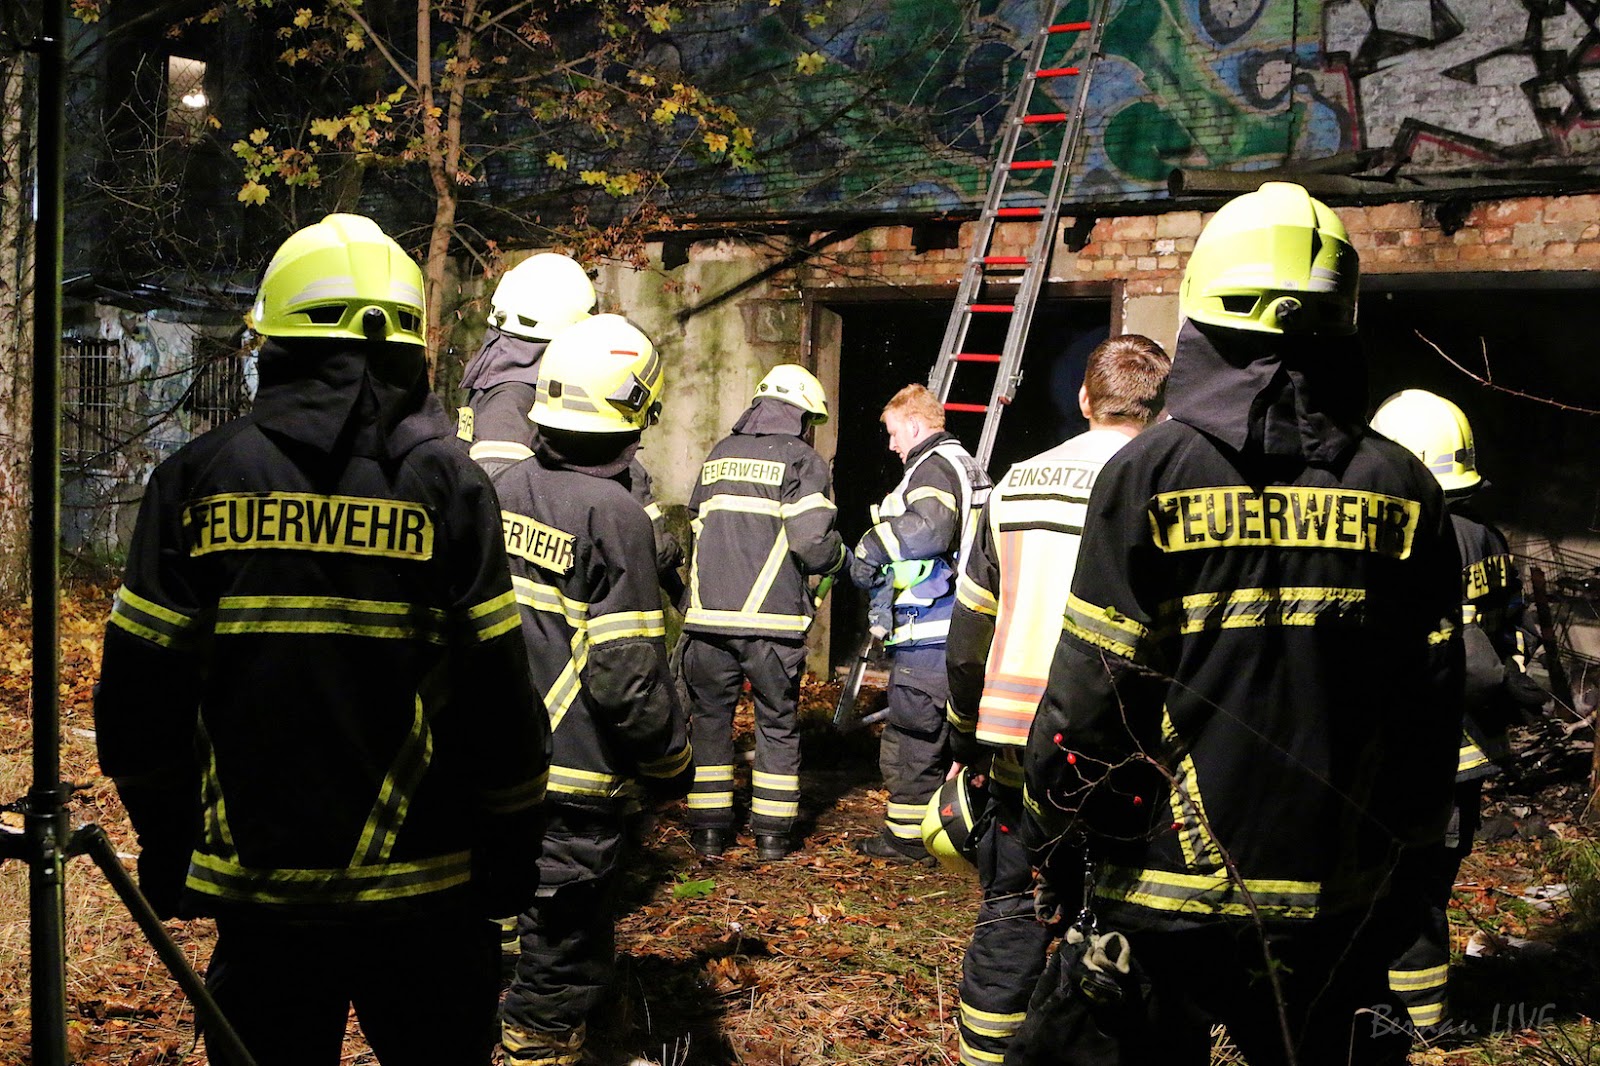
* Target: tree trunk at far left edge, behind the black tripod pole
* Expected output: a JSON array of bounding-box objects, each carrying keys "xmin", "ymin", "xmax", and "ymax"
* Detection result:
[{"xmin": 0, "ymin": 56, "xmax": 34, "ymax": 602}]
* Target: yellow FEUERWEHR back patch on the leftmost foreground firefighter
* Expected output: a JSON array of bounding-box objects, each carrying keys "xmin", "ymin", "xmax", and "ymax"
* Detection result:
[{"xmin": 184, "ymin": 493, "xmax": 434, "ymax": 560}]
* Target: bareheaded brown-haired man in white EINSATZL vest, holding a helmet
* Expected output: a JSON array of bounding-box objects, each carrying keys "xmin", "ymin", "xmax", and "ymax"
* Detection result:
[{"xmin": 923, "ymin": 335, "xmax": 1171, "ymax": 1066}]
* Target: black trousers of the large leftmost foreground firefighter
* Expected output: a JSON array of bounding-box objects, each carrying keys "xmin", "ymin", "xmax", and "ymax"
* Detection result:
[{"xmin": 205, "ymin": 916, "xmax": 499, "ymax": 1066}]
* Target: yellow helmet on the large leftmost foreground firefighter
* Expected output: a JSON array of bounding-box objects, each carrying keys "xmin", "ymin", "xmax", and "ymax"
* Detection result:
[{"xmin": 248, "ymin": 214, "xmax": 427, "ymax": 344}]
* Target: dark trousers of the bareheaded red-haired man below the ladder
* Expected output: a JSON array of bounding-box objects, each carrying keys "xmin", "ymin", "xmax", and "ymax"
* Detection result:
[{"xmin": 878, "ymin": 645, "xmax": 950, "ymax": 853}]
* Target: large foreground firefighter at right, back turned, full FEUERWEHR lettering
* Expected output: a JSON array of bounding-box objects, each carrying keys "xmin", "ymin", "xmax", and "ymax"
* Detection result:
[{"xmin": 1024, "ymin": 182, "xmax": 1461, "ymax": 1066}]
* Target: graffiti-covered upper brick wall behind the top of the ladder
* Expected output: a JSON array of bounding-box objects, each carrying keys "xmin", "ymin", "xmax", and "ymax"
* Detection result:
[{"xmin": 556, "ymin": 0, "xmax": 1600, "ymax": 218}]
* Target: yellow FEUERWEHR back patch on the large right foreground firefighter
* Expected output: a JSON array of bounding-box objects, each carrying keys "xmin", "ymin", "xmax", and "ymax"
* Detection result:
[{"xmin": 1147, "ymin": 485, "xmax": 1422, "ymax": 559}]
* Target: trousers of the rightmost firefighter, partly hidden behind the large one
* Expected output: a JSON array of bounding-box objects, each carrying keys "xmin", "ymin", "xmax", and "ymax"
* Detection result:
[{"xmin": 1389, "ymin": 778, "xmax": 1483, "ymax": 1034}]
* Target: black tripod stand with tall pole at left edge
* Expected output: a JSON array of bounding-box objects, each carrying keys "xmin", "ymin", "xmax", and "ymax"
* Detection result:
[{"xmin": 0, "ymin": 0, "xmax": 254, "ymax": 1066}]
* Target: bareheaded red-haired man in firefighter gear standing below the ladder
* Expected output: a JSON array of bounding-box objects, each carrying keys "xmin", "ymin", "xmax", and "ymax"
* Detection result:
[{"xmin": 850, "ymin": 384, "xmax": 989, "ymax": 861}]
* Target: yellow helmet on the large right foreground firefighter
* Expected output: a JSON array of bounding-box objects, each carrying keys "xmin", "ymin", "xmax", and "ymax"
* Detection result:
[{"xmin": 1178, "ymin": 181, "xmax": 1360, "ymax": 333}]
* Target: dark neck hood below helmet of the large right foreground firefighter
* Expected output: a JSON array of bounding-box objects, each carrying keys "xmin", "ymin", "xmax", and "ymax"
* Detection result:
[{"xmin": 1166, "ymin": 322, "xmax": 1366, "ymax": 466}]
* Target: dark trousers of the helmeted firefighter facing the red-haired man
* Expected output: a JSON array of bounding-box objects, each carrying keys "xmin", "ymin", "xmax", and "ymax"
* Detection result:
[{"xmin": 683, "ymin": 634, "xmax": 805, "ymax": 836}]
